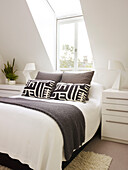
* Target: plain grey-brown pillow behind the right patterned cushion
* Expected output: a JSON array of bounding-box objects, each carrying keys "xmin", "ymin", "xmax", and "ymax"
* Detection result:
[{"xmin": 61, "ymin": 71, "xmax": 94, "ymax": 84}]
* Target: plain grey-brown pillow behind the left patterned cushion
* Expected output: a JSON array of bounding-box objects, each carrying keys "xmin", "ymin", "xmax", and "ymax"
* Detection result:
[{"xmin": 35, "ymin": 71, "xmax": 62, "ymax": 83}]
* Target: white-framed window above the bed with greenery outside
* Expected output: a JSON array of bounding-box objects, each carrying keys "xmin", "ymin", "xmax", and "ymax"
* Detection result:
[{"xmin": 57, "ymin": 17, "xmax": 93, "ymax": 70}]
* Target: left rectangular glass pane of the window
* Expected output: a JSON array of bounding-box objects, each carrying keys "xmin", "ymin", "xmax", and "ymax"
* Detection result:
[{"xmin": 59, "ymin": 23, "xmax": 75, "ymax": 69}]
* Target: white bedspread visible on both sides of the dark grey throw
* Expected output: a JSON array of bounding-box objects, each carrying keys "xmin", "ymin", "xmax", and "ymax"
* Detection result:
[{"xmin": 0, "ymin": 83, "xmax": 102, "ymax": 170}]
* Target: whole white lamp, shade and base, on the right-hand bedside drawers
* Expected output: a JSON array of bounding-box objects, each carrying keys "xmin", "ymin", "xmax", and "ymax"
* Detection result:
[{"xmin": 108, "ymin": 60, "xmax": 125, "ymax": 90}]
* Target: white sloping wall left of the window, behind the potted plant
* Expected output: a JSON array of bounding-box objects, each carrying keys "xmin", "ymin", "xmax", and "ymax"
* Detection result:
[{"xmin": 0, "ymin": 0, "xmax": 53, "ymax": 82}]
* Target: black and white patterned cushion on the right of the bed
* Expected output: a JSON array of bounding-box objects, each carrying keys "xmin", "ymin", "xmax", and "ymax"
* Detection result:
[{"xmin": 50, "ymin": 83, "xmax": 90, "ymax": 102}]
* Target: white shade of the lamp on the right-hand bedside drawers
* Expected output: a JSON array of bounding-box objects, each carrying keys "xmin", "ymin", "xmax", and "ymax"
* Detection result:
[{"xmin": 108, "ymin": 60, "xmax": 125, "ymax": 71}]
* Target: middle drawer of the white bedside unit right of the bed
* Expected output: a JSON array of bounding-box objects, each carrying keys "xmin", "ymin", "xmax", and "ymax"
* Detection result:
[{"xmin": 102, "ymin": 103, "xmax": 128, "ymax": 117}]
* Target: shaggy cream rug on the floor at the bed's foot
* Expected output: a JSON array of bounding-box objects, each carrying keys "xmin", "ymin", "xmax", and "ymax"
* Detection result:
[{"xmin": 0, "ymin": 151, "xmax": 112, "ymax": 170}]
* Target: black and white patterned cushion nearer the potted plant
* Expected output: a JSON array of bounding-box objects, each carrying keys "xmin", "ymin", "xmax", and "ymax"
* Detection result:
[{"xmin": 22, "ymin": 80, "xmax": 55, "ymax": 99}]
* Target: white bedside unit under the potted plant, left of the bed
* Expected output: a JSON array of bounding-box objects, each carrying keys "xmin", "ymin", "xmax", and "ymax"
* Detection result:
[{"xmin": 0, "ymin": 84, "xmax": 25, "ymax": 97}]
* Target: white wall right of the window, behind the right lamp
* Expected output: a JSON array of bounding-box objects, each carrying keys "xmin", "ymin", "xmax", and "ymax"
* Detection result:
[{"xmin": 80, "ymin": 0, "xmax": 128, "ymax": 88}]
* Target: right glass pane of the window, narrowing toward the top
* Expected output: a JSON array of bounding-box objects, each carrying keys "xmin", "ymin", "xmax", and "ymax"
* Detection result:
[{"xmin": 77, "ymin": 21, "xmax": 93, "ymax": 69}]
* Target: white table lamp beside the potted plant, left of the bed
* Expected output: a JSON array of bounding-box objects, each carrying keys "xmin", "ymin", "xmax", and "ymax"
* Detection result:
[{"xmin": 23, "ymin": 63, "xmax": 36, "ymax": 83}]
